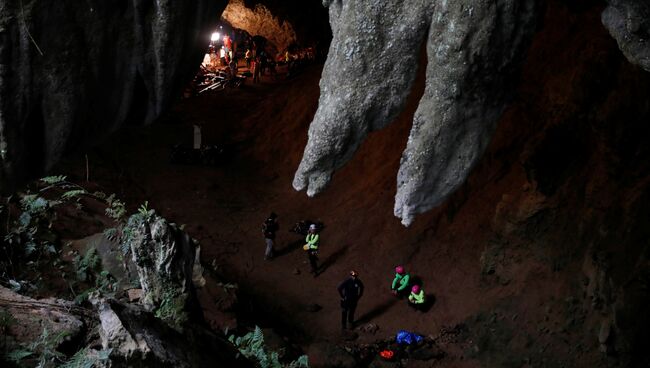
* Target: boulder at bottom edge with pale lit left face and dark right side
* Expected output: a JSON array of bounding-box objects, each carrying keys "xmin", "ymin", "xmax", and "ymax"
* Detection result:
[{"xmin": 92, "ymin": 298, "xmax": 253, "ymax": 367}]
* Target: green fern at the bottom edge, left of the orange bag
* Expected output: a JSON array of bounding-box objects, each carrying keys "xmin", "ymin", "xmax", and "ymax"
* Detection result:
[{"xmin": 228, "ymin": 326, "xmax": 309, "ymax": 368}]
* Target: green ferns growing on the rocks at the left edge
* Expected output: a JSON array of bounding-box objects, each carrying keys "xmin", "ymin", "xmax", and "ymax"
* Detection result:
[{"xmin": 0, "ymin": 175, "xmax": 126, "ymax": 293}]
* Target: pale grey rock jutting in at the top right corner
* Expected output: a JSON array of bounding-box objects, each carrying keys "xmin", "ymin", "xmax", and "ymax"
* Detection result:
[{"xmin": 601, "ymin": 0, "xmax": 650, "ymax": 72}]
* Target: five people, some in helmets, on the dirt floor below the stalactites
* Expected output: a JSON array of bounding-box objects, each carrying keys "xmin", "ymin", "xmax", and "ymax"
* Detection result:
[{"xmin": 262, "ymin": 212, "xmax": 426, "ymax": 330}]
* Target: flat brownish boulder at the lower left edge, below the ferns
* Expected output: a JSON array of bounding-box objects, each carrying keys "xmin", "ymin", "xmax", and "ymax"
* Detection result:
[{"xmin": 0, "ymin": 286, "xmax": 84, "ymax": 350}]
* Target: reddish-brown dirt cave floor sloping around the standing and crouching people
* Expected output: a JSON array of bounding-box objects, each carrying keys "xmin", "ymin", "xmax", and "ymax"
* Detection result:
[{"xmin": 53, "ymin": 65, "xmax": 481, "ymax": 356}]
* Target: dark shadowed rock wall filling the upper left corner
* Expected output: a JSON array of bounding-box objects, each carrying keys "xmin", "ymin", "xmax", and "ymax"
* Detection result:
[{"xmin": 0, "ymin": 0, "xmax": 226, "ymax": 190}]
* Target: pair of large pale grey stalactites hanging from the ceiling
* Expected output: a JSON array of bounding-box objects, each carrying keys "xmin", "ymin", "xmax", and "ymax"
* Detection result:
[{"xmin": 293, "ymin": 0, "xmax": 538, "ymax": 225}]
